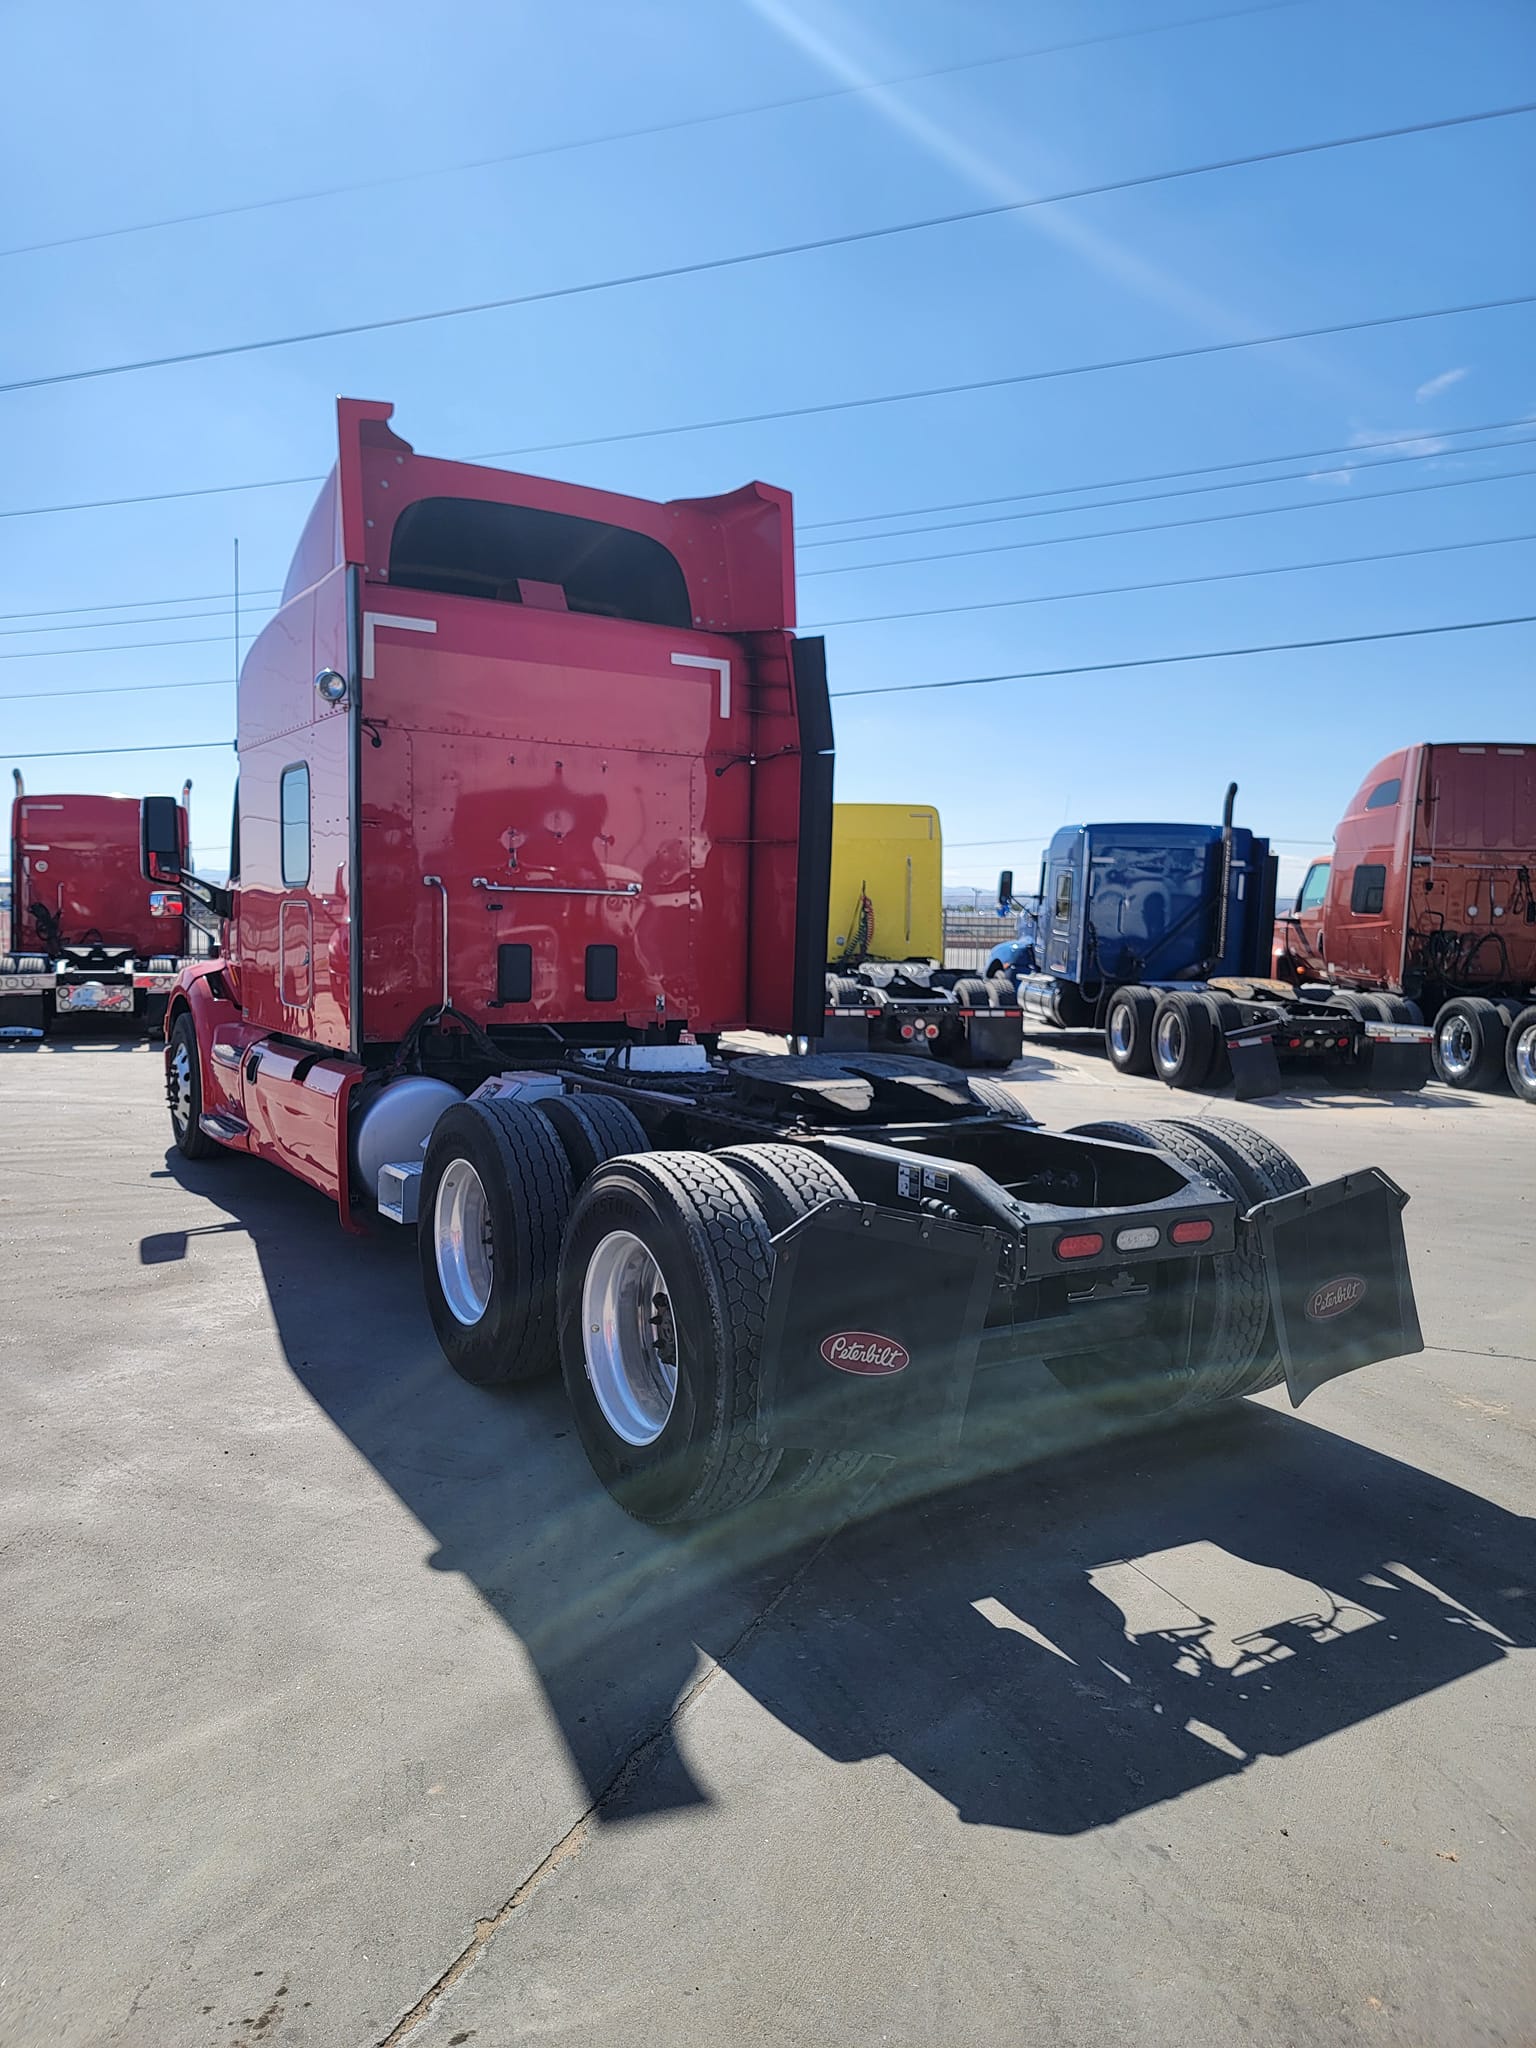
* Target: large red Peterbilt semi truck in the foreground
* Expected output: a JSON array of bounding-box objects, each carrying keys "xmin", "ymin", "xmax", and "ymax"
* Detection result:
[{"xmin": 141, "ymin": 399, "xmax": 1419, "ymax": 1524}]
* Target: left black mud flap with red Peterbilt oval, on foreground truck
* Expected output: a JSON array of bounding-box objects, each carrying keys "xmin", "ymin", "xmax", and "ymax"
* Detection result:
[{"xmin": 758, "ymin": 1202, "xmax": 1001, "ymax": 1460}]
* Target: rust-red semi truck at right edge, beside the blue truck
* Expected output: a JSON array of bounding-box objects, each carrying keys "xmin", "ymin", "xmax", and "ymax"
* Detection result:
[{"xmin": 1276, "ymin": 739, "xmax": 1536, "ymax": 1102}]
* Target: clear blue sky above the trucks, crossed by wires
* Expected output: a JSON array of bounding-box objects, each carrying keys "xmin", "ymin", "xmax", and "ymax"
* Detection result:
[{"xmin": 0, "ymin": 0, "xmax": 1536, "ymax": 883}]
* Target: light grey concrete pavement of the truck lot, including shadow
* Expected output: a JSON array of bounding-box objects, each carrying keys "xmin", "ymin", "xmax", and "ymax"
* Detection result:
[{"xmin": 0, "ymin": 1042, "xmax": 1536, "ymax": 2048}]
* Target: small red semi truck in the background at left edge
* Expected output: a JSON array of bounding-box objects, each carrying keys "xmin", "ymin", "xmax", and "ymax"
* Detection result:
[{"xmin": 0, "ymin": 768, "xmax": 193, "ymax": 1036}]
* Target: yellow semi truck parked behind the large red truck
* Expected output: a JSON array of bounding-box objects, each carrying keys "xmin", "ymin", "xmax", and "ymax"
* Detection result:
[{"xmin": 821, "ymin": 803, "xmax": 1024, "ymax": 1067}]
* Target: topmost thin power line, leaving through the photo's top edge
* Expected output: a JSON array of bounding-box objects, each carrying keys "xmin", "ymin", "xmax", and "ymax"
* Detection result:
[{"xmin": 0, "ymin": 0, "xmax": 1307, "ymax": 256}]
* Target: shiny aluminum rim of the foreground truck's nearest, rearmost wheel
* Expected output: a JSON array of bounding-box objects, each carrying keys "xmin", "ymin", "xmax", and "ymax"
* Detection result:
[{"xmin": 582, "ymin": 1231, "xmax": 678, "ymax": 1450}]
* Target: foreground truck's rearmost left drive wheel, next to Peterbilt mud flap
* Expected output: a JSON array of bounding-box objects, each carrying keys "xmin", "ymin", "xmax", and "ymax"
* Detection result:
[{"xmin": 559, "ymin": 1151, "xmax": 780, "ymax": 1526}]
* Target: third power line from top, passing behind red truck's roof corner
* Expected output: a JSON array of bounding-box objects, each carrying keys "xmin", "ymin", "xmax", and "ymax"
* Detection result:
[{"xmin": 12, "ymin": 293, "xmax": 1536, "ymax": 528}]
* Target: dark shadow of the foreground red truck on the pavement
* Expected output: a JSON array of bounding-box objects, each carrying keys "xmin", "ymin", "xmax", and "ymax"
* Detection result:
[{"xmin": 150, "ymin": 1153, "xmax": 1536, "ymax": 1835}]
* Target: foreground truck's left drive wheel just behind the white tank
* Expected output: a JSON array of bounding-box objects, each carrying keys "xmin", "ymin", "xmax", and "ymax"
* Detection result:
[{"xmin": 418, "ymin": 1098, "xmax": 571, "ymax": 1386}]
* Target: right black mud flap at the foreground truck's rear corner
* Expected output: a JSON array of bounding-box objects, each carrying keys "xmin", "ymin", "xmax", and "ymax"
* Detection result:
[{"xmin": 1243, "ymin": 1165, "xmax": 1423, "ymax": 1407}]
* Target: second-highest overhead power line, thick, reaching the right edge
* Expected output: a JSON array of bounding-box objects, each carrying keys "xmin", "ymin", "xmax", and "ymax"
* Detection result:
[{"xmin": 0, "ymin": 100, "xmax": 1536, "ymax": 393}]
